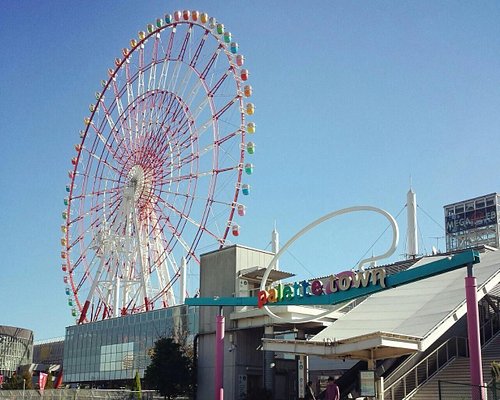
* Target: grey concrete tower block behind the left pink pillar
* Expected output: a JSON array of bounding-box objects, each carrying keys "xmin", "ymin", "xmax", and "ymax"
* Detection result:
[{"xmin": 197, "ymin": 246, "xmax": 273, "ymax": 400}]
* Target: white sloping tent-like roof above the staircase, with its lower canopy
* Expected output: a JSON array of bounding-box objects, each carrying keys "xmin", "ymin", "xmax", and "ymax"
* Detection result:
[{"xmin": 264, "ymin": 251, "xmax": 500, "ymax": 359}]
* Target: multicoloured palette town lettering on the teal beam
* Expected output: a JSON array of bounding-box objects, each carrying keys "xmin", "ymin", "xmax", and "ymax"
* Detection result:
[{"xmin": 257, "ymin": 268, "xmax": 386, "ymax": 308}]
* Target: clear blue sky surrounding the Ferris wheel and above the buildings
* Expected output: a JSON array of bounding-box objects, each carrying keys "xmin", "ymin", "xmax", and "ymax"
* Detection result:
[{"xmin": 0, "ymin": 0, "xmax": 500, "ymax": 340}]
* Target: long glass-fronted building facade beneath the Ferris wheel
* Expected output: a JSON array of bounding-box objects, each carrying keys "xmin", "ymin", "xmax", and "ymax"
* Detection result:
[{"xmin": 63, "ymin": 305, "xmax": 198, "ymax": 387}]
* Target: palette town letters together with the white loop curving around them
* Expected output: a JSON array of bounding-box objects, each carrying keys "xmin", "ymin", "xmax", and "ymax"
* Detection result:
[{"xmin": 257, "ymin": 206, "xmax": 399, "ymax": 323}]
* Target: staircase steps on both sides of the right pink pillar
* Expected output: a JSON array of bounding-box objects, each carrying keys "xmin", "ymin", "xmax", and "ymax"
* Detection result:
[{"xmin": 407, "ymin": 335, "xmax": 500, "ymax": 400}]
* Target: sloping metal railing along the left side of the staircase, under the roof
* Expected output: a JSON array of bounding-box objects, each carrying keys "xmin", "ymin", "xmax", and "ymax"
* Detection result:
[{"xmin": 384, "ymin": 337, "xmax": 468, "ymax": 400}]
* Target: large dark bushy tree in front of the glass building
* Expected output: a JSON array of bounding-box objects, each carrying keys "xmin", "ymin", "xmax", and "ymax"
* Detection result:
[{"xmin": 144, "ymin": 338, "xmax": 193, "ymax": 399}]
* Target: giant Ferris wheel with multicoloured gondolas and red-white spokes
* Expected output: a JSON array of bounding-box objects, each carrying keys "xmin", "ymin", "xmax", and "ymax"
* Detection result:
[{"xmin": 61, "ymin": 11, "xmax": 256, "ymax": 323}]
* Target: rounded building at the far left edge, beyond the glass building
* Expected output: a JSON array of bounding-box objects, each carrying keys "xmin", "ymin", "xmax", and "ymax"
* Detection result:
[{"xmin": 0, "ymin": 325, "xmax": 33, "ymax": 378}]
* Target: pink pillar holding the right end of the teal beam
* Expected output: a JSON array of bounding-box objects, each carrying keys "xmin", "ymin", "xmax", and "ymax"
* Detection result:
[{"xmin": 465, "ymin": 267, "xmax": 485, "ymax": 400}]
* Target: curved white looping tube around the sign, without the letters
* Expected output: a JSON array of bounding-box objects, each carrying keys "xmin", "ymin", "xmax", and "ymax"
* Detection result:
[{"xmin": 260, "ymin": 206, "xmax": 399, "ymax": 323}]
